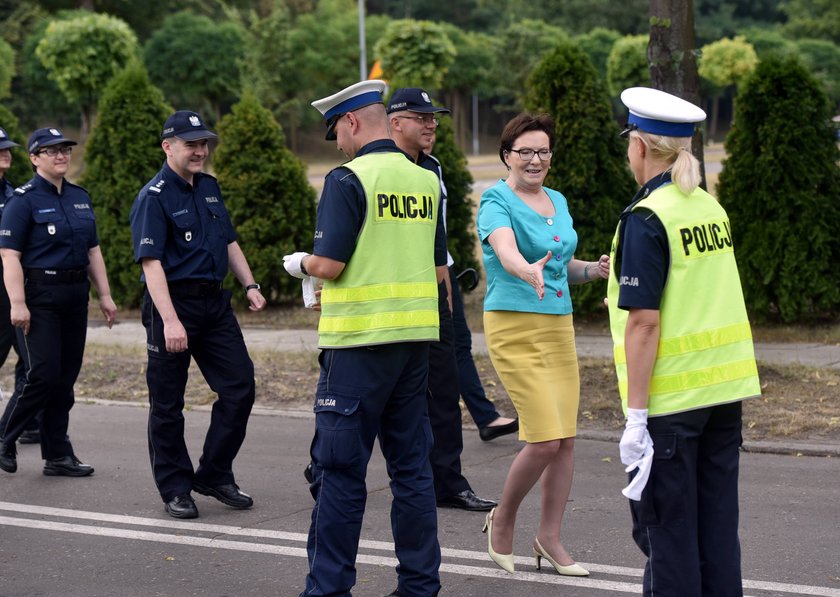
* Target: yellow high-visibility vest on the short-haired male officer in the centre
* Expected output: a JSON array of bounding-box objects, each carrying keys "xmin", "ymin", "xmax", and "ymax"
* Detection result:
[{"xmin": 318, "ymin": 152, "xmax": 440, "ymax": 348}]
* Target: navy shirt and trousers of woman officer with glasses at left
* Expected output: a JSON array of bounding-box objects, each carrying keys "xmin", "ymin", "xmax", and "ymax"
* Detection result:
[{"xmin": 0, "ymin": 174, "xmax": 99, "ymax": 460}]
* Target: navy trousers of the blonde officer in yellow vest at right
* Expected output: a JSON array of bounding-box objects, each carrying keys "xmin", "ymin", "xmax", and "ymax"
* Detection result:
[{"xmin": 630, "ymin": 402, "xmax": 744, "ymax": 597}]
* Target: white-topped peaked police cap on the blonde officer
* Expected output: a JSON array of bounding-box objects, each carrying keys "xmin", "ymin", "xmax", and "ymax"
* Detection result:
[{"xmin": 621, "ymin": 87, "xmax": 706, "ymax": 137}]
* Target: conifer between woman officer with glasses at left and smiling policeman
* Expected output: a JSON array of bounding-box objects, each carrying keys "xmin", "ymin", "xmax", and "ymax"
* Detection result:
[{"xmin": 81, "ymin": 61, "xmax": 172, "ymax": 307}]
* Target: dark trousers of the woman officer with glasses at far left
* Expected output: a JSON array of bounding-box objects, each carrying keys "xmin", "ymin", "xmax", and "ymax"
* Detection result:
[{"xmin": 0, "ymin": 279, "xmax": 90, "ymax": 459}]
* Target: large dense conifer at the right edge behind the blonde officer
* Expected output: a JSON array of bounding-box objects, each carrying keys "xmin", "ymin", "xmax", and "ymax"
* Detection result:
[{"xmin": 718, "ymin": 55, "xmax": 840, "ymax": 322}]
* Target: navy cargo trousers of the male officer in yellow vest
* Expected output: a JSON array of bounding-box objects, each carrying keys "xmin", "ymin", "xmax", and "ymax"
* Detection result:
[{"xmin": 301, "ymin": 342, "xmax": 440, "ymax": 597}]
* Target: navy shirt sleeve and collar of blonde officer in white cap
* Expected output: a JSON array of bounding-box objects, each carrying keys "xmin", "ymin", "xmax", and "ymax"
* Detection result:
[{"xmin": 615, "ymin": 171, "xmax": 673, "ymax": 310}]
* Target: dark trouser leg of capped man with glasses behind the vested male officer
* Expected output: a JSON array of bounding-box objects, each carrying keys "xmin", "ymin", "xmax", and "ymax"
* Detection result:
[{"xmin": 427, "ymin": 281, "xmax": 470, "ymax": 499}]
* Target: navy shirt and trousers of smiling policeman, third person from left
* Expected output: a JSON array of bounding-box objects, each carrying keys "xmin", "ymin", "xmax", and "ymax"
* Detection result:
[{"xmin": 131, "ymin": 163, "xmax": 255, "ymax": 502}]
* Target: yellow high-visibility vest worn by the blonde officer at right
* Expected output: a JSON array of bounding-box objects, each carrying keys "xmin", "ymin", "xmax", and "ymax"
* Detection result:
[{"xmin": 607, "ymin": 184, "xmax": 761, "ymax": 416}]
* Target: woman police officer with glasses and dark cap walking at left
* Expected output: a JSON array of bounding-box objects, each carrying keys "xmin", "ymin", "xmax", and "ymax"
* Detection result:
[{"xmin": 0, "ymin": 128, "xmax": 117, "ymax": 477}]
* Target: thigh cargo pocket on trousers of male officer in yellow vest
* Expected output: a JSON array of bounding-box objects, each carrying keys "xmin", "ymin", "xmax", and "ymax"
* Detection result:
[{"xmin": 312, "ymin": 392, "xmax": 362, "ymax": 469}]
